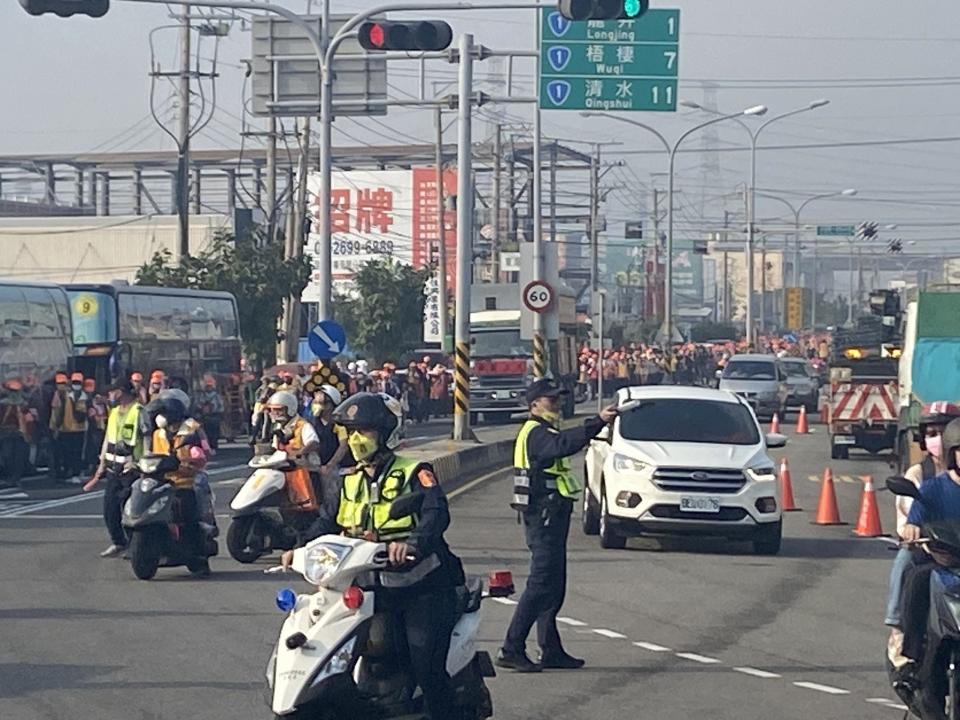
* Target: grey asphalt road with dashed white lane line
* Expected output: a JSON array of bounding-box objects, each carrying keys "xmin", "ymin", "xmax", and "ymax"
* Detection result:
[{"xmin": 0, "ymin": 416, "xmax": 902, "ymax": 720}]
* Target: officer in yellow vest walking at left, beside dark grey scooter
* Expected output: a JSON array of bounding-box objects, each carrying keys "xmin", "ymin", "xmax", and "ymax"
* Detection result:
[{"xmin": 83, "ymin": 380, "xmax": 143, "ymax": 558}]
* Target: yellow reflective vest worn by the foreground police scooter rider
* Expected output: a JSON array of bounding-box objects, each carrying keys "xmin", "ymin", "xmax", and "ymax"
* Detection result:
[{"xmin": 337, "ymin": 456, "xmax": 421, "ymax": 541}]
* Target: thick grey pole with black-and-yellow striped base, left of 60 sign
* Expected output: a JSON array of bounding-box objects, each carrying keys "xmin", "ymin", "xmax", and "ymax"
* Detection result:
[{"xmin": 453, "ymin": 33, "xmax": 474, "ymax": 440}]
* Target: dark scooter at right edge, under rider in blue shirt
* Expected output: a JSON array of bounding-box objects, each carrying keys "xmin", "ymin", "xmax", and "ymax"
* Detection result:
[{"xmin": 886, "ymin": 477, "xmax": 960, "ymax": 720}]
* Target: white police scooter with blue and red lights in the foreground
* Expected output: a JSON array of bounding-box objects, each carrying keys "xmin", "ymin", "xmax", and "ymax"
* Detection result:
[{"xmin": 266, "ymin": 495, "xmax": 513, "ymax": 720}]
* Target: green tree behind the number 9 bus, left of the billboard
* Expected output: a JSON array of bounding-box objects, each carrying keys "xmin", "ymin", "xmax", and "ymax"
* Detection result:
[{"xmin": 136, "ymin": 232, "xmax": 310, "ymax": 368}]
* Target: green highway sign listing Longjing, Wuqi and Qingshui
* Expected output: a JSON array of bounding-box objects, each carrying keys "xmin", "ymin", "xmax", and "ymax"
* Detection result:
[{"xmin": 540, "ymin": 8, "xmax": 680, "ymax": 111}]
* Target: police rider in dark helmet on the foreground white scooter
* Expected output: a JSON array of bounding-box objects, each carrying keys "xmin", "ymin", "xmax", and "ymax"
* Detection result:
[{"xmin": 283, "ymin": 393, "xmax": 465, "ymax": 720}]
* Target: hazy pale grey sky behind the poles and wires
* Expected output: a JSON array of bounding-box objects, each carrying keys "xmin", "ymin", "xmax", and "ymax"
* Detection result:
[{"xmin": 0, "ymin": 0, "xmax": 960, "ymax": 264}]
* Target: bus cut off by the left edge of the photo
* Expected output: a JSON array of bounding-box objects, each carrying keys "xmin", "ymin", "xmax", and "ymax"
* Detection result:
[{"xmin": 0, "ymin": 280, "xmax": 73, "ymax": 392}]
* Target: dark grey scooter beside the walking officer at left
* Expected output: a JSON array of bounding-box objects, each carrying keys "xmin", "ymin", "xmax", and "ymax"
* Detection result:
[{"xmin": 123, "ymin": 455, "xmax": 219, "ymax": 580}]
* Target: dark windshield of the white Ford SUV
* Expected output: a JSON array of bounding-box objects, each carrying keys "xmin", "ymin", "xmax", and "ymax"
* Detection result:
[{"xmin": 620, "ymin": 398, "xmax": 760, "ymax": 445}]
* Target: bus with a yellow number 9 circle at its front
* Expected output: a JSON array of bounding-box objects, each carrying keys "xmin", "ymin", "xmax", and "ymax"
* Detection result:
[{"xmin": 65, "ymin": 282, "xmax": 241, "ymax": 392}]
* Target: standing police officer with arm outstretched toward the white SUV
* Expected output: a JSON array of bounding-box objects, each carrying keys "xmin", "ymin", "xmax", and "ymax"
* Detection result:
[{"xmin": 496, "ymin": 378, "xmax": 617, "ymax": 672}]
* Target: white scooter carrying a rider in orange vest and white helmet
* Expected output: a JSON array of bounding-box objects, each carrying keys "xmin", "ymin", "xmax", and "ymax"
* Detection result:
[{"xmin": 227, "ymin": 446, "xmax": 317, "ymax": 563}]
